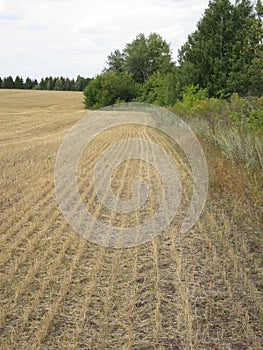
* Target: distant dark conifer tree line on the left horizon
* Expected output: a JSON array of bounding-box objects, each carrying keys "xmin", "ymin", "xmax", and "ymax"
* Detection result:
[{"xmin": 0, "ymin": 75, "xmax": 91, "ymax": 91}]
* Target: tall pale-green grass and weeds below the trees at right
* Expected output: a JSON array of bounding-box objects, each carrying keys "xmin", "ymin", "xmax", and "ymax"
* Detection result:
[{"xmin": 173, "ymin": 87, "xmax": 263, "ymax": 170}]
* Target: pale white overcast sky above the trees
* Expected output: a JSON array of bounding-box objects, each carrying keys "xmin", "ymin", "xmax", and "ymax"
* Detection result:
[{"xmin": 0, "ymin": 0, "xmax": 217, "ymax": 79}]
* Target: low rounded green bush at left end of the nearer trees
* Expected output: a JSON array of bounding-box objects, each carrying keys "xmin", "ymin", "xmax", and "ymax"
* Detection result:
[{"xmin": 84, "ymin": 72, "xmax": 135, "ymax": 109}]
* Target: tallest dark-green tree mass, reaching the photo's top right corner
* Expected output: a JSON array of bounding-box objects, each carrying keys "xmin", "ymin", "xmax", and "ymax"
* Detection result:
[{"xmin": 179, "ymin": 0, "xmax": 262, "ymax": 97}]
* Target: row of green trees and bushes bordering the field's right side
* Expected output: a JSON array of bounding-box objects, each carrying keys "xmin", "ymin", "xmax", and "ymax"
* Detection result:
[{"xmin": 84, "ymin": 0, "xmax": 263, "ymax": 108}]
